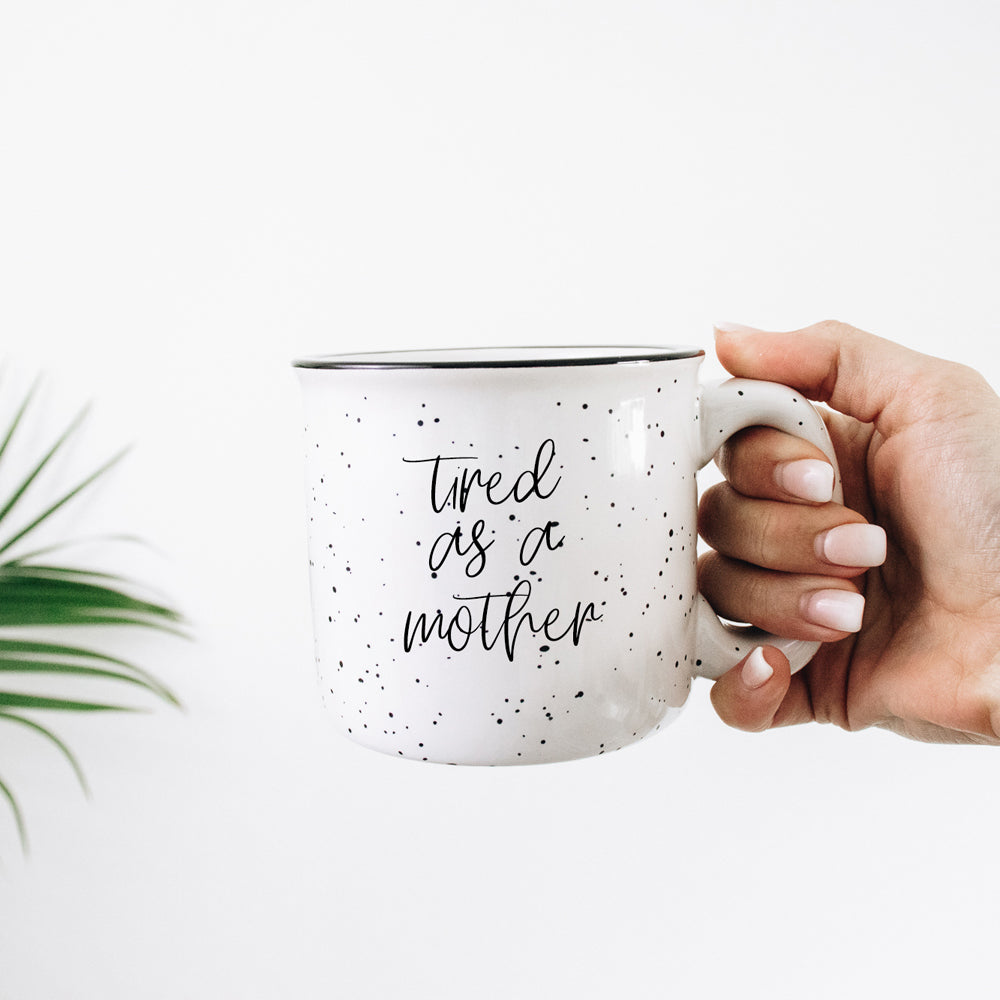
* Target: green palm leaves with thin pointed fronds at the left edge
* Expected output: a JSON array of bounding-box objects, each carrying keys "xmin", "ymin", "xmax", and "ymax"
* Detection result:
[{"xmin": 0, "ymin": 382, "xmax": 182, "ymax": 850}]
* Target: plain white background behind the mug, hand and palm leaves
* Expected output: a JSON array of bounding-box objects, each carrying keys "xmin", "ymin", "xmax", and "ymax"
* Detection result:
[{"xmin": 0, "ymin": 0, "xmax": 1000, "ymax": 1000}]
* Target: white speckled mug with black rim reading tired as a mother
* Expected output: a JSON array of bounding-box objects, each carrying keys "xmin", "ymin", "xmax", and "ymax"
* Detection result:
[{"xmin": 294, "ymin": 347, "xmax": 842, "ymax": 764}]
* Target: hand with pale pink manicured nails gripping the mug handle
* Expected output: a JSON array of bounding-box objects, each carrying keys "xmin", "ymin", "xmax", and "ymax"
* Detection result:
[{"xmin": 699, "ymin": 322, "xmax": 1000, "ymax": 745}]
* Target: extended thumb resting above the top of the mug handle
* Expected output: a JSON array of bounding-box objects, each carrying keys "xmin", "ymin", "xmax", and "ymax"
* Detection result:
[{"xmin": 715, "ymin": 320, "xmax": 932, "ymax": 435}]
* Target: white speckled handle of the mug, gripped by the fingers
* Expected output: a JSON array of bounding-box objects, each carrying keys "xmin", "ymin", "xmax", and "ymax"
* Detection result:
[{"xmin": 695, "ymin": 378, "xmax": 844, "ymax": 680}]
